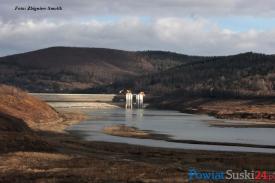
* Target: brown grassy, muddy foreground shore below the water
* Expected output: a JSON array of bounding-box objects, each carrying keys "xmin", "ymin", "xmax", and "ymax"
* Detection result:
[{"xmin": 0, "ymin": 104, "xmax": 275, "ymax": 183}]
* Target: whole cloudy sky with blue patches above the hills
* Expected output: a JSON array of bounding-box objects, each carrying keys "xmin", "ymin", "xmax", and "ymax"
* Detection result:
[{"xmin": 0, "ymin": 0, "xmax": 275, "ymax": 56}]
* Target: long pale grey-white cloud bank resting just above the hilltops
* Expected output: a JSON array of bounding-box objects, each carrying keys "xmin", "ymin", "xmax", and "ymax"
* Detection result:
[{"xmin": 0, "ymin": 18, "xmax": 275, "ymax": 55}]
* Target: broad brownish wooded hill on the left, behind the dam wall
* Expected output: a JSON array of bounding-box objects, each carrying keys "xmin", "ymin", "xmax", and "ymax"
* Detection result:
[{"xmin": 0, "ymin": 47, "xmax": 205, "ymax": 92}]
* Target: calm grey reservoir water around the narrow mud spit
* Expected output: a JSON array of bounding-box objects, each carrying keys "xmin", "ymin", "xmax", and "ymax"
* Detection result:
[{"xmin": 67, "ymin": 108, "xmax": 275, "ymax": 153}]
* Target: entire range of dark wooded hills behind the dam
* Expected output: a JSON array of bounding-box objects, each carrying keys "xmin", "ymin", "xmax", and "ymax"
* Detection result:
[{"xmin": 0, "ymin": 47, "xmax": 275, "ymax": 97}]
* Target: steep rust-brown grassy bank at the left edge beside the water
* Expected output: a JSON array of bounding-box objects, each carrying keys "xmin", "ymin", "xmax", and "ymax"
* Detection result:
[{"xmin": 0, "ymin": 85, "xmax": 62, "ymax": 153}]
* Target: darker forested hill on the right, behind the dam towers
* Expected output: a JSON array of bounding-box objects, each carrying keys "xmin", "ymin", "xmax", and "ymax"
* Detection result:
[{"xmin": 92, "ymin": 52, "xmax": 275, "ymax": 97}]
